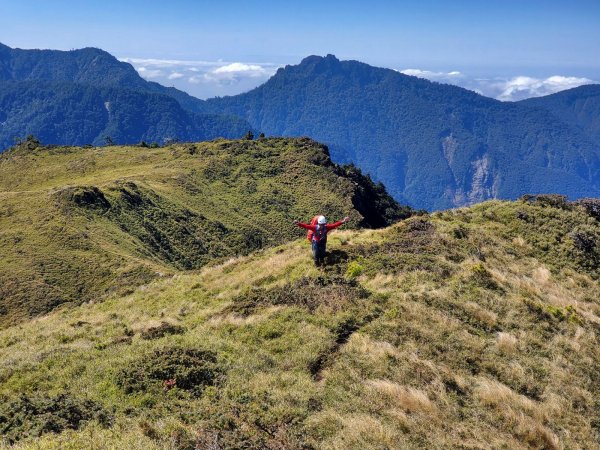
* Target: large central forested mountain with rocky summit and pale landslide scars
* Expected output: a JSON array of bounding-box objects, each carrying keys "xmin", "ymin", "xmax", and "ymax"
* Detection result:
[{"xmin": 198, "ymin": 55, "xmax": 600, "ymax": 209}]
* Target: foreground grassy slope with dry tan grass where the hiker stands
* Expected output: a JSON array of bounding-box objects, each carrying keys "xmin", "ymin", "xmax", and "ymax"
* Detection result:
[{"xmin": 0, "ymin": 202, "xmax": 600, "ymax": 449}]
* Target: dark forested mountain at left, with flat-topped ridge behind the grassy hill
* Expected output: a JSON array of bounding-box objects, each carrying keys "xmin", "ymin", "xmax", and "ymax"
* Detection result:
[{"xmin": 0, "ymin": 44, "xmax": 251, "ymax": 151}]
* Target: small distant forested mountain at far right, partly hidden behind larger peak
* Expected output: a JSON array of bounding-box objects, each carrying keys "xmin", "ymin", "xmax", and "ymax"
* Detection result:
[{"xmin": 519, "ymin": 84, "xmax": 600, "ymax": 145}]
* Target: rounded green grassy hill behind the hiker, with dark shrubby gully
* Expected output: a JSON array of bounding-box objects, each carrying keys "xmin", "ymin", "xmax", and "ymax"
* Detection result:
[{"xmin": 0, "ymin": 139, "xmax": 408, "ymax": 326}]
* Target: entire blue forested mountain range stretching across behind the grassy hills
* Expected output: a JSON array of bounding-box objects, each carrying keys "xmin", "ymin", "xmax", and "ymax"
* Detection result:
[{"xmin": 0, "ymin": 45, "xmax": 600, "ymax": 209}]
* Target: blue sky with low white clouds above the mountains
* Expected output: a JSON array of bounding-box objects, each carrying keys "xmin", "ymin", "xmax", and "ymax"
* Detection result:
[{"xmin": 0, "ymin": 0, "xmax": 600, "ymax": 100}]
